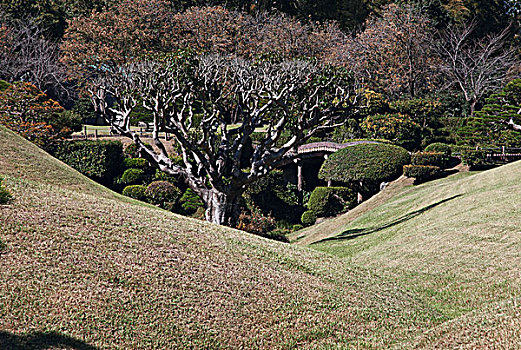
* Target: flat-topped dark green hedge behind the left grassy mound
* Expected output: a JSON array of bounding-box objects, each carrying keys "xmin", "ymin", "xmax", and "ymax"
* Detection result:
[{"xmin": 54, "ymin": 140, "xmax": 123, "ymax": 184}]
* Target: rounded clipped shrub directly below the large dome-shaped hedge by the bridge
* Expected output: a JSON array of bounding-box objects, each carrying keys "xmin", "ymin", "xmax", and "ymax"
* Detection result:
[{"xmin": 308, "ymin": 187, "xmax": 356, "ymax": 216}]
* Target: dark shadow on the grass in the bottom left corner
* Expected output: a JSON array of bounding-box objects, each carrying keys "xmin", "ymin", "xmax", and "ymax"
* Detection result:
[{"xmin": 0, "ymin": 331, "xmax": 98, "ymax": 350}]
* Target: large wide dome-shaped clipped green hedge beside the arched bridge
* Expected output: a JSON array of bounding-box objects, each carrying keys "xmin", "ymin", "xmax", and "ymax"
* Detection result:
[{"xmin": 318, "ymin": 143, "xmax": 410, "ymax": 183}]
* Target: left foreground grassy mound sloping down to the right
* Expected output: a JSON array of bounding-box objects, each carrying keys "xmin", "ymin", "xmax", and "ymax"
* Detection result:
[{"xmin": 0, "ymin": 127, "xmax": 442, "ymax": 349}]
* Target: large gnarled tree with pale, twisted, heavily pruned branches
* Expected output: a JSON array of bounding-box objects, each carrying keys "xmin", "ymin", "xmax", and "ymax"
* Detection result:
[{"xmin": 92, "ymin": 55, "xmax": 356, "ymax": 225}]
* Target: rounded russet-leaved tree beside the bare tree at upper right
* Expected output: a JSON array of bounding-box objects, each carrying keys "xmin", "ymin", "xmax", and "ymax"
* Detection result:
[{"xmin": 327, "ymin": 4, "xmax": 437, "ymax": 97}]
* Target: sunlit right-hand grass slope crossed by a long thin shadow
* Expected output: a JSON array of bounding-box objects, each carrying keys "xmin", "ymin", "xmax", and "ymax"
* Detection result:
[{"xmin": 311, "ymin": 162, "xmax": 521, "ymax": 348}]
